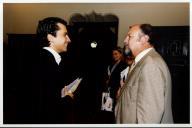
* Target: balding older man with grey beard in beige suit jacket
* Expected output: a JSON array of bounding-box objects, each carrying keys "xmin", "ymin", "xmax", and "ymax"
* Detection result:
[{"xmin": 115, "ymin": 24, "xmax": 173, "ymax": 123}]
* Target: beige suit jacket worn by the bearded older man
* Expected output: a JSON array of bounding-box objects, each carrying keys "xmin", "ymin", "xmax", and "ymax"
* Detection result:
[{"xmin": 115, "ymin": 49, "xmax": 173, "ymax": 123}]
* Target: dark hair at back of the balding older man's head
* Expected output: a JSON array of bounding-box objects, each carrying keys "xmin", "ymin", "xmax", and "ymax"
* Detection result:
[{"xmin": 140, "ymin": 24, "xmax": 153, "ymax": 44}]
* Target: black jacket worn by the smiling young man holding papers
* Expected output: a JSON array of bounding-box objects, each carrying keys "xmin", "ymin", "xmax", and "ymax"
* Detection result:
[{"xmin": 39, "ymin": 49, "xmax": 72, "ymax": 124}]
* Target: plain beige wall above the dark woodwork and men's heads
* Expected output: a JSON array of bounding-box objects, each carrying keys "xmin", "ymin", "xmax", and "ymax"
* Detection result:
[{"xmin": 3, "ymin": 3, "xmax": 189, "ymax": 46}]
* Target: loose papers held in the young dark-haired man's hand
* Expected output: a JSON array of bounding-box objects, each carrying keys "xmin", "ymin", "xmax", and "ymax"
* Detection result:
[{"xmin": 61, "ymin": 78, "xmax": 82, "ymax": 98}]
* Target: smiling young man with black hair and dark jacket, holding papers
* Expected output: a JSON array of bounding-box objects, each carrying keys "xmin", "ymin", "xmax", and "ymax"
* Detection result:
[{"xmin": 37, "ymin": 17, "xmax": 73, "ymax": 124}]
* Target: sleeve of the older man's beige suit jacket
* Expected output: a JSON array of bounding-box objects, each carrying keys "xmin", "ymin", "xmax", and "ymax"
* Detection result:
[{"xmin": 136, "ymin": 62, "xmax": 165, "ymax": 123}]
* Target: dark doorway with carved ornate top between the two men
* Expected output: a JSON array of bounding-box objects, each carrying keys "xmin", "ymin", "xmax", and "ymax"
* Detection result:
[{"xmin": 65, "ymin": 13, "xmax": 118, "ymax": 123}]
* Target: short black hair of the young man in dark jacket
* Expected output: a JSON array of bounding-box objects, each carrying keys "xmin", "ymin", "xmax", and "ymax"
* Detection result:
[{"xmin": 36, "ymin": 17, "xmax": 67, "ymax": 47}]
